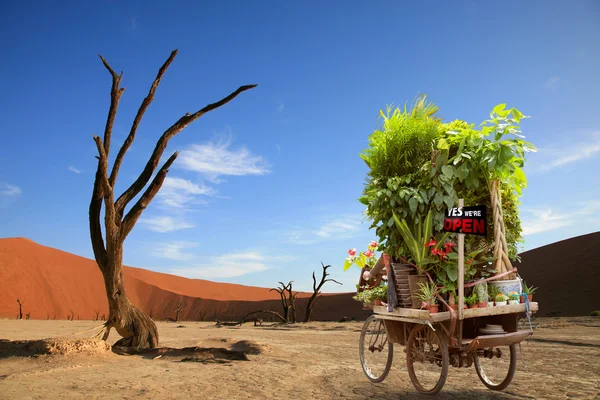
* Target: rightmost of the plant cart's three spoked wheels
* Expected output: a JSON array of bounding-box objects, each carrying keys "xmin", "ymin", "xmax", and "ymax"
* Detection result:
[{"xmin": 474, "ymin": 344, "xmax": 517, "ymax": 390}]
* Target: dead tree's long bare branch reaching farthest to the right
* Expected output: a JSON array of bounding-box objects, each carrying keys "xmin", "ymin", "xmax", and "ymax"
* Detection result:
[{"xmin": 116, "ymin": 85, "xmax": 257, "ymax": 214}]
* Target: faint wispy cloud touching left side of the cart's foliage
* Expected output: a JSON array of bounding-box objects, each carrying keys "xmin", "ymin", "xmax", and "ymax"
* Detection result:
[{"xmin": 287, "ymin": 217, "xmax": 361, "ymax": 244}]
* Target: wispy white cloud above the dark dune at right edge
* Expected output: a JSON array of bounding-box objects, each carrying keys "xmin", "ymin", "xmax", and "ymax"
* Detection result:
[{"xmin": 523, "ymin": 200, "xmax": 600, "ymax": 236}]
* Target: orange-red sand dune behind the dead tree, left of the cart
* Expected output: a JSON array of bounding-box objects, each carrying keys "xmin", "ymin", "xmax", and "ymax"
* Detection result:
[{"xmin": 0, "ymin": 238, "xmax": 365, "ymax": 320}]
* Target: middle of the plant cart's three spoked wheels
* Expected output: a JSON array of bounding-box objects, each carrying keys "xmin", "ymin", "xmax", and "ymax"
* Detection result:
[{"xmin": 406, "ymin": 325, "xmax": 449, "ymax": 395}]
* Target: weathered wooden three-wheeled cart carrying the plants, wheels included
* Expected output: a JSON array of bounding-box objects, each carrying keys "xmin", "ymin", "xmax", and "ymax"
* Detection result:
[{"xmin": 359, "ymin": 199, "xmax": 538, "ymax": 395}]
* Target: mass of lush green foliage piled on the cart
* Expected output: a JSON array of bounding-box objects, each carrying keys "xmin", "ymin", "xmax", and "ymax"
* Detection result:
[{"xmin": 359, "ymin": 96, "xmax": 536, "ymax": 284}]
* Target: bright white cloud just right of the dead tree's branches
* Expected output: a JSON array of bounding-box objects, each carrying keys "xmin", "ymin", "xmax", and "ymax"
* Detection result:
[{"xmin": 176, "ymin": 140, "xmax": 270, "ymax": 182}]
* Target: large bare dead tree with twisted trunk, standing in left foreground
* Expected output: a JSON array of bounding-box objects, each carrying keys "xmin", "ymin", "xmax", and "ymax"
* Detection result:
[{"xmin": 89, "ymin": 50, "xmax": 256, "ymax": 348}]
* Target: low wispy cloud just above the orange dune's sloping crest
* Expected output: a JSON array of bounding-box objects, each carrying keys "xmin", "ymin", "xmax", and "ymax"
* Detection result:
[{"xmin": 169, "ymin": 251, "xmax": 291, "ymax": 279}]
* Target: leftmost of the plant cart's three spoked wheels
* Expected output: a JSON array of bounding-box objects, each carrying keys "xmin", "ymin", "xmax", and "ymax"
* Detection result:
[{"xmin": 359, "ymin": 315, "xmax": 394, "ymax": 383}]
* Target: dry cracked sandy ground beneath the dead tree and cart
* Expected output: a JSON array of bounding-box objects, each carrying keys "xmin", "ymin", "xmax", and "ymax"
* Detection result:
[{"xmin": 0, "ymin": 318, "xmax": 600, "ymax": 400}]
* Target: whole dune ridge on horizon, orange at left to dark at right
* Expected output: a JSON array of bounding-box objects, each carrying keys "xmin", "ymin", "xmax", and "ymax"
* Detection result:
[{"xmin": 0, "ymin": 232, "xmax": 600, "ymax": 321}]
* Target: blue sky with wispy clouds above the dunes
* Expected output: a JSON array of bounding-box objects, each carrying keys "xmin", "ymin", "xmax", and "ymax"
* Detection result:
[{"xmin": 0, "ymin": 1, "xmax": 600, "ymax": 291}]
